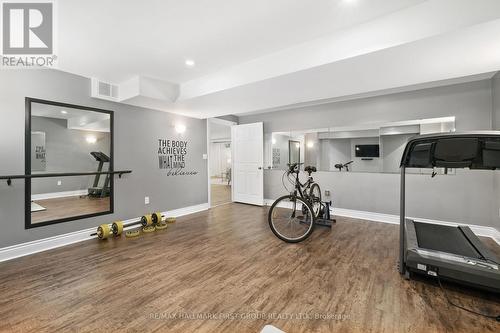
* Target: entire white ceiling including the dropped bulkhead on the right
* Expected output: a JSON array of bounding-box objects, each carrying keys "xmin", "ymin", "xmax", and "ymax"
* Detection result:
[{"xmin": 58, "ymin": 0, "xmax": 500, "ymax": 118}]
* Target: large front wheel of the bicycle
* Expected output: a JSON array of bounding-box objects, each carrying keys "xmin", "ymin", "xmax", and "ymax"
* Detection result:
[{"xmin": 268, "ymin": 195, "xmax": 315, "ymax": 243}]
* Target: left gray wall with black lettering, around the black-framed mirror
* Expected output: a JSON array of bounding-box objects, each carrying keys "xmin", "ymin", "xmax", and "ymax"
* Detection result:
[{"xmin": 0, "ymin": 70, "xmax": 208, "ymax": 248}]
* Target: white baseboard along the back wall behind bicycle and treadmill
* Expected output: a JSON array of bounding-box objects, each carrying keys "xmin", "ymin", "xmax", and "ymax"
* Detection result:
[{"xmin": 264, "ymin": 199, "xmax": 500, "ymax": 245}]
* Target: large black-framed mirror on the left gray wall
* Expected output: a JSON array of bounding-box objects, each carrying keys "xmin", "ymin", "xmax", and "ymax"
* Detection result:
[{"xmin": 25, "ymin": 98, "xmax": 113, "ymax": 229}]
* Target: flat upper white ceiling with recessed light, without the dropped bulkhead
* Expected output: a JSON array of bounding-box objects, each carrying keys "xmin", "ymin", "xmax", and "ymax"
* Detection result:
[{"xmin": 58, "ymin": 0, "xmax": 424, "ymax": 83}]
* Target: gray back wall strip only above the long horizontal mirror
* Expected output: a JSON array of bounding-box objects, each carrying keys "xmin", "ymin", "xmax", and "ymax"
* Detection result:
[{"xmin": 239, "ymin": 80, "xmax": 492, "ymax": 133}]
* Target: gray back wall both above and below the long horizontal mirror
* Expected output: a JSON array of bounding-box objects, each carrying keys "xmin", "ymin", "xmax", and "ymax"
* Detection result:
[{"xmin": 239, "ymin": 80, "xmax": 500, "ymax": 229}]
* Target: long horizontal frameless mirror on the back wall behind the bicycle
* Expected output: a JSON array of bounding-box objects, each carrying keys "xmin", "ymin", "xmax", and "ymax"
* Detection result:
[{"xmin": 265, "ymin": 117, "xmax": 455, "ymax": 174}]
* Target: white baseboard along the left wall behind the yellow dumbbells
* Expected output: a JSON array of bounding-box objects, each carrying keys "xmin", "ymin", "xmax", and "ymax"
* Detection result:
[{"xmin": 0, "ymin": 203, "xmax": 208, "ymax": 262}]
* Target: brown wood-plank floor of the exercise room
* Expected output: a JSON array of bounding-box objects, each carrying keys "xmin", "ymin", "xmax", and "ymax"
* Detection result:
[{"xmin": 0, "ymin": 204, "xmax": 500, "ymax": 332}]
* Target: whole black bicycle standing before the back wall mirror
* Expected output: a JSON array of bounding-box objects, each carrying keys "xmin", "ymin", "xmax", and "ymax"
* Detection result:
[{"xmin": 268, "ymin": 163, "xmax": 335, "ymax": 243}]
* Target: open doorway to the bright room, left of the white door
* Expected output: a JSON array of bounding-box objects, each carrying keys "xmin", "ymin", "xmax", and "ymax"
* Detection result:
[{"xmin": 207, "ymin": 118, "xmax": 236, "ymax": 207}]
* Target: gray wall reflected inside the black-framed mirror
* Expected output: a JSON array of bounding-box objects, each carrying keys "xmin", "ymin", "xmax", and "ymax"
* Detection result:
[{"xmin": 31, "ymin": 116, "xmax": 111, "ymax": 194}]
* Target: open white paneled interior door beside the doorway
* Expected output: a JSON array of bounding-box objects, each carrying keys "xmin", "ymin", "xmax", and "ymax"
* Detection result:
[{"xmin": 231, "ymin": 123, "xmax": 264, "ymax": 206}]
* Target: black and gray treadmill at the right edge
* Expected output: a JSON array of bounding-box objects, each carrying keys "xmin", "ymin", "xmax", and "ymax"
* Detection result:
[{"xmin": 399, "ymin": 131, "xmax": 500, "ymax": 293}]
